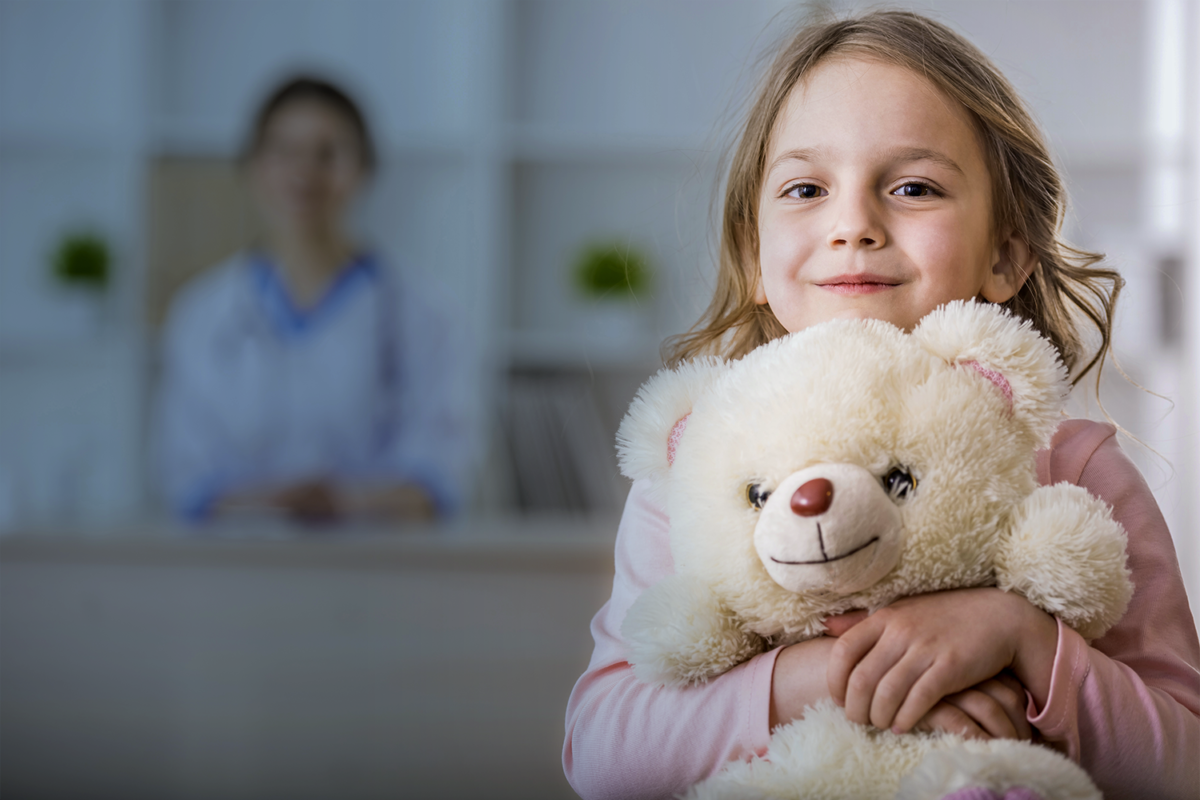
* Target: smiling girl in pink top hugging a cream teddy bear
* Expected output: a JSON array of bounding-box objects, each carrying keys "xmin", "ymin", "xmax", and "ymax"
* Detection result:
[{"xmin": 563, "ymin": 12, "xmax": 1200, "ymax": 800}]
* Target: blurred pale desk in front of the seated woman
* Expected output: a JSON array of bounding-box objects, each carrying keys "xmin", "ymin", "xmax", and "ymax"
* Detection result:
[{"xmin": 0, "ymin": 518, "xmax": 617, "ymax": 800}]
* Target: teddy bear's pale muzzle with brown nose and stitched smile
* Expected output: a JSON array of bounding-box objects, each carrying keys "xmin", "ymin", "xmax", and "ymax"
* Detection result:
[{"xmin": 754, "ymin": 464, "xmax": 902, "ymax": 595}]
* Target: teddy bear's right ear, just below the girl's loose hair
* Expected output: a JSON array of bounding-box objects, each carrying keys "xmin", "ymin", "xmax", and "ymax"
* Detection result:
[{"xmin": 912, "ymin": 300, "xmax": 1070, "ymax": 445}]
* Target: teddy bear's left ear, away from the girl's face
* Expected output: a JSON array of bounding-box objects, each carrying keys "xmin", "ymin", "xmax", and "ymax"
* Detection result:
[{"xmin": 617, "ymin": 357, "xmax": 727, "ymax": 481}]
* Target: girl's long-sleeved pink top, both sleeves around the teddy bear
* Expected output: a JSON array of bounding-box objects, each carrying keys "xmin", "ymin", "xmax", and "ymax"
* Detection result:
[{"xmin": 563, "ymin": 420, "xmax": 1200, "ymax": 800}]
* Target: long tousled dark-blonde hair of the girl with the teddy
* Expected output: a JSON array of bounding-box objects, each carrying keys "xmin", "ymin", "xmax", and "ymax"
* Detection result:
[{"xmin": 664, "ymin": 11, "xmax": 1123, "ymax": 383}]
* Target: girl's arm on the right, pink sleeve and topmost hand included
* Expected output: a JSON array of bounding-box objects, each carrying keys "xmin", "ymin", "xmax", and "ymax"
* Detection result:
[{"xmin": 829, "ymin": 421, "xmax": 1200, "ymax": 798}]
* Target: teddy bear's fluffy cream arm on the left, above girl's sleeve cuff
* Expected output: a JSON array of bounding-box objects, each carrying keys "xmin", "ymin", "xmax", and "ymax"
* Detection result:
[{"xmin": 620, "ymin": 575, "xmax": 764, "ymax": 686}]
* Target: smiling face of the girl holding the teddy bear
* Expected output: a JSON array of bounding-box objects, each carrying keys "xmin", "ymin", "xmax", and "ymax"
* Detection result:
[{"xmin": 756, "ymin": 58, "xmax": 1032, "ymax": 332}]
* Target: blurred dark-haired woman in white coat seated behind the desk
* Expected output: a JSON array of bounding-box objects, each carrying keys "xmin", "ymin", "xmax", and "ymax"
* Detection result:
[{"xmin": 156, "ymin": 77, "xmax": 478, "ymax": 522}]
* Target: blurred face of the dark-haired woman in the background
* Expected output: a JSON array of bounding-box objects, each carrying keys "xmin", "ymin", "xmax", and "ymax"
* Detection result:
[{"xmin": 250, "ymin": 100, "xmax": 366, "ymax": 235}]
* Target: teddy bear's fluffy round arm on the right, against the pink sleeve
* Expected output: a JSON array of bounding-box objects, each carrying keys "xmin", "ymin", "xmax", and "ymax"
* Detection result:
[{"xmin": 996, "ymin": 483, "xmax": 1133, "ymax": 639}]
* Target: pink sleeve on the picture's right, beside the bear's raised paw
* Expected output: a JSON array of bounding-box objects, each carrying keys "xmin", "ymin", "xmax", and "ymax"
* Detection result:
[{"xmin": 1030, "ymin": 421, "xmax": 1200, "ymax": 800}]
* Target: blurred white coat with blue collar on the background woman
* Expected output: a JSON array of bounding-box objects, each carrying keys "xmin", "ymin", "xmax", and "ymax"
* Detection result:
[{"xmin": 156, "ymin": 253, "xmax": 479, "ymax": 518}]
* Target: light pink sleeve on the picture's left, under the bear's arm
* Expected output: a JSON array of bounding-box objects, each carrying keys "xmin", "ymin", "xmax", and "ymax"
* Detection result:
[{"xmin": 563, "ymin": 481, "xmax": 779, "ymax": 800}]
